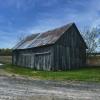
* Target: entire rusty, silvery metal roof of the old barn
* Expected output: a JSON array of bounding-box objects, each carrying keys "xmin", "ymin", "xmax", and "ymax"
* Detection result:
[{"xmin": 13, "ymin": 23, "xmax": 85, "ymax": 49}]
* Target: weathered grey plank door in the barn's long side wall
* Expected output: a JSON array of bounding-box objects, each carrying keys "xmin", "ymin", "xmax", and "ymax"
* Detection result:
[{"xmin": 34, "ymin": 53, "xmax": 51, "ymax": 70}]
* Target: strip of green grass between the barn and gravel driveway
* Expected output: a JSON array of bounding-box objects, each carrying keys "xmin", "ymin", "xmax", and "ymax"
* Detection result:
[{"xmin": 4, "ymin": 65, "xmax": 100, "ymax": 82}]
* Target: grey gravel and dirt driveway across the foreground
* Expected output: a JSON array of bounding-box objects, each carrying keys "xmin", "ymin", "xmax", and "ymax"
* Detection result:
[{"xmin": 0, "ymin": 76, "xmax": 100, "ymax": 100}]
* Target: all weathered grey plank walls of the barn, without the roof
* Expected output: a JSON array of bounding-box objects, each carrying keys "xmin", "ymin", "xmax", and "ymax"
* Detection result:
[{"xmin": 13, "ymin": 25, "xmax": 86, "ymax": 70}]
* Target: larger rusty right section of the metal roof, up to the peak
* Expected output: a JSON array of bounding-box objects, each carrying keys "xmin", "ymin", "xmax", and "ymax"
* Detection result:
[{"xmin": 28, "ymin": 23, "xmax": 73, "ymax": 48}]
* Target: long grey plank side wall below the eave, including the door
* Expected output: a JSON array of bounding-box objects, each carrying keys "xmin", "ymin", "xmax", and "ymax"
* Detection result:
[{"xmin": 13, "ymin": 46, "xmax": 53, "ymax": 70}]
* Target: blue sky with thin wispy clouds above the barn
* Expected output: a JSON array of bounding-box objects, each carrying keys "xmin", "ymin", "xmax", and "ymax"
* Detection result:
[{"xmin": 0, "ymin": 0, "xmax": 100, "ymax": 48}]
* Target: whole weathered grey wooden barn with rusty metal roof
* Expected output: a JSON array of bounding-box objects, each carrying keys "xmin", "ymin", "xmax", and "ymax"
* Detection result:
[{"xmin": 12, "ymin": 23, "xmax": 87, "ymax": 71}]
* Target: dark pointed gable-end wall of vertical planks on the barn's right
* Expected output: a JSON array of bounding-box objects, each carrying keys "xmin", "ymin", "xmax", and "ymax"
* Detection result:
[{"xmin": 54, "ymin": 26, "xmax": 86, "ymax": 70}]
